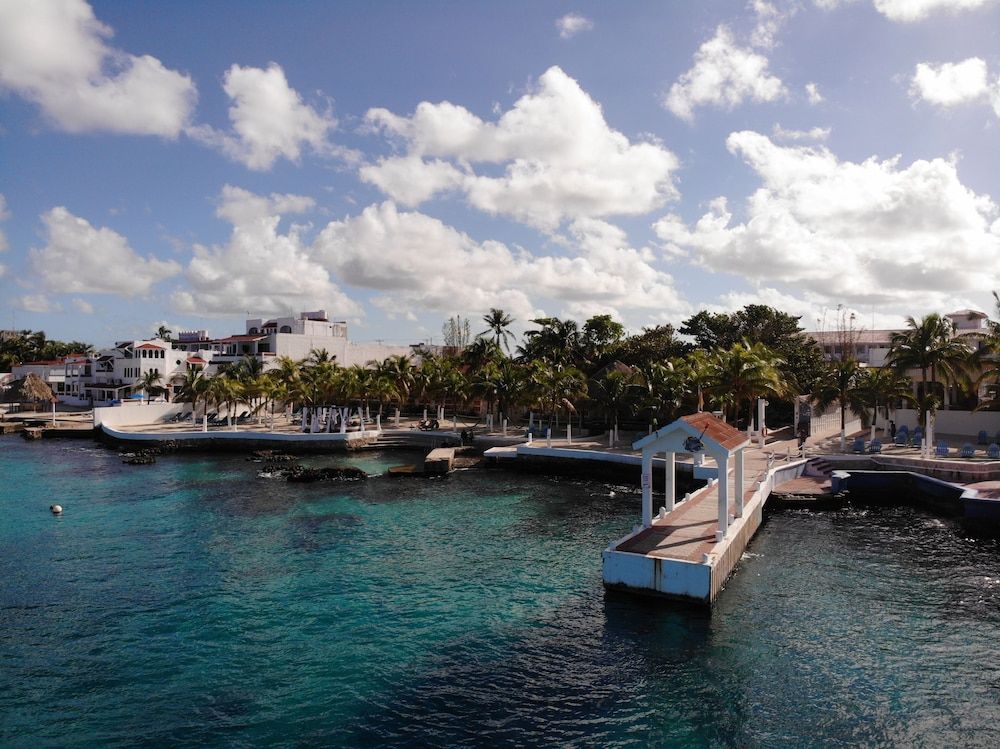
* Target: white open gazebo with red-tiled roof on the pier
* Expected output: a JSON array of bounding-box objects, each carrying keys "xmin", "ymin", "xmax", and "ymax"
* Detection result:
[{"xmin": 632, "ymin": 411, "xmax": 750, "ymax": 541}]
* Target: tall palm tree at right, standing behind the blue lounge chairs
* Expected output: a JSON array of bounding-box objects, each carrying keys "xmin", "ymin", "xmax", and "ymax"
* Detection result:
[{"xmin": 887, "ymin": 313, "xmax": 972, "ymax": 424}]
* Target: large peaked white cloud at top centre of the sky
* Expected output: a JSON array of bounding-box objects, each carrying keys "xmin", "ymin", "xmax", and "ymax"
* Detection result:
[{"xmin": 360, "ymin": 67, "xmax": 678, "ymax": 231}]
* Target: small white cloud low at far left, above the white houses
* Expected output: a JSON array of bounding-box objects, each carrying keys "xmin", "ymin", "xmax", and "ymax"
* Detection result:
[{"xmin": 29, "ymin": 206, "xmax": 180, "ymax": 297}]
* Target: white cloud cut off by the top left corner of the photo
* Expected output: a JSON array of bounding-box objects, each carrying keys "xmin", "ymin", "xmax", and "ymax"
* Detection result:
[{"xmin": 0, "ymin": 0, "xmax": 197, "ymax": 138}]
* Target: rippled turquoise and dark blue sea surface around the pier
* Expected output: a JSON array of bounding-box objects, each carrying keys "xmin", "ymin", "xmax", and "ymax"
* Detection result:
[{"xmin": 0, "ymin": 437, "xmax": 1000, "ymax": 749}]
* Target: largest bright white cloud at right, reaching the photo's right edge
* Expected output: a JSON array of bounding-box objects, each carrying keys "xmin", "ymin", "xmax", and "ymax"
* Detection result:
[{"xmin": 654, "ymin": 132, "xmax": 1000, "ymax": 308}]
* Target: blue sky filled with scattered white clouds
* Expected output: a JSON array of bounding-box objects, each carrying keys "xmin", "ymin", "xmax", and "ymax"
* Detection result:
[{"xmin": 0, "ymin": 0, "xmax": 1000, "ymax": 346}]
